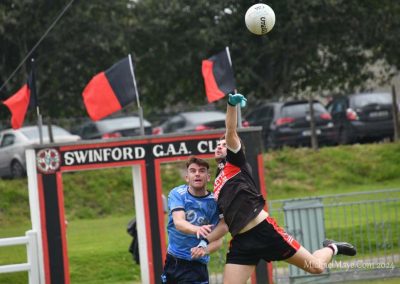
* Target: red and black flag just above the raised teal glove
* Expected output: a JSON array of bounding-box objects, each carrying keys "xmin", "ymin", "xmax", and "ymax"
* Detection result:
[{"xmin": 201, "ymin": 48, "xmax": 236, "ymax": 103}]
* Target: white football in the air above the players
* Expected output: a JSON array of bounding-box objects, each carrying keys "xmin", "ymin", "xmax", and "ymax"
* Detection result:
[{"xmin": 244, "ymin": 3, "xmax": 275, "ymax": 35}]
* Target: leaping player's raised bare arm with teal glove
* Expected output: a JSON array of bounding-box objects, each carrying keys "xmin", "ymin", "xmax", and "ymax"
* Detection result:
[{"xmin": 225, "ymin": 94, "xmax": 247, "ymax": 150}]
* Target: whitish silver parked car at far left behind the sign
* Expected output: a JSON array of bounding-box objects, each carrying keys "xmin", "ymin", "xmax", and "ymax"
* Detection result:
[{"xmin": 0, "ymin": 125, "xmax": 80, "ymax": 178}]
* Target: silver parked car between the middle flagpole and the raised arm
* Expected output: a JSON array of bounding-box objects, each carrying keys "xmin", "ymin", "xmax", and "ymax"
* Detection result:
[{"xmin": 153, "ymin": 111, "xmax": 247, "ymax": 134}]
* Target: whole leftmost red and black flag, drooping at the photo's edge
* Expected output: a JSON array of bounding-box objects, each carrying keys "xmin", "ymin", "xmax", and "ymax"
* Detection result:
[{"xmin": 3, "ymin": 69, "xmax": 37, "ymax": 129}]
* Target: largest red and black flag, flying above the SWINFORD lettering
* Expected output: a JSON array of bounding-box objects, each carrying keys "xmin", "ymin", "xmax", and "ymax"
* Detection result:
[{"xmin": 82, "ymin": 56, "xmax": 137, "ymax": 120}]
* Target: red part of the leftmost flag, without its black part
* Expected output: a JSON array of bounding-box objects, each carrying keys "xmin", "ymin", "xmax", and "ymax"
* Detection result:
[{"xmin": 3, "ymin": 84, "xmax": 31, "ymax": 129}]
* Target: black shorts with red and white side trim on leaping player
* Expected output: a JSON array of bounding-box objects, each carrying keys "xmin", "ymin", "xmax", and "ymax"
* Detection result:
[{"xmin": 226, "ymin": 217, "xmax": 300, "ymax": 265}]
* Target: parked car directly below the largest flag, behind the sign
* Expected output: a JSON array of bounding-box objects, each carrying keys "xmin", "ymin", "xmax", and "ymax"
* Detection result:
[{"xmin": 72, "ymin": 116, "xmax": 152, "ymax": 139}]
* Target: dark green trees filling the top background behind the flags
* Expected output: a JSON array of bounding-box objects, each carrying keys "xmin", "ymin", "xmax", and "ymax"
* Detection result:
[{"xmin": 0, "ymin": 0, "xmax": 400, "ymax": 125}]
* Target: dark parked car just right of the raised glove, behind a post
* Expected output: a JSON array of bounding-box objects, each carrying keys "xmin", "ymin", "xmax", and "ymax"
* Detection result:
[{"xmin": 246, "ymin": 101, "xmax": 335, "ymax": 149}]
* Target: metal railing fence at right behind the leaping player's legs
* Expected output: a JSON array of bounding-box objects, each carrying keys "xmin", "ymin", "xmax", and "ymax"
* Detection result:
[{"xmin": 210, "ymin": 189, "xmax": 400, "ymax": 283}]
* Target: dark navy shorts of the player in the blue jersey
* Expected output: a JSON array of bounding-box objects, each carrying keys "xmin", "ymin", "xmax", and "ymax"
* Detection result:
[{"xmin": 161, "ymin": 254, "xmax": 208, "ymax": 284}]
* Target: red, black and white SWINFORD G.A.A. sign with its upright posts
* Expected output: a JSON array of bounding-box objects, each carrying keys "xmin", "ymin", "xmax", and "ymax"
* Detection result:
[{"xmin": 27, "ymin": 128, "xmax": 271, "ymax": 284}]
